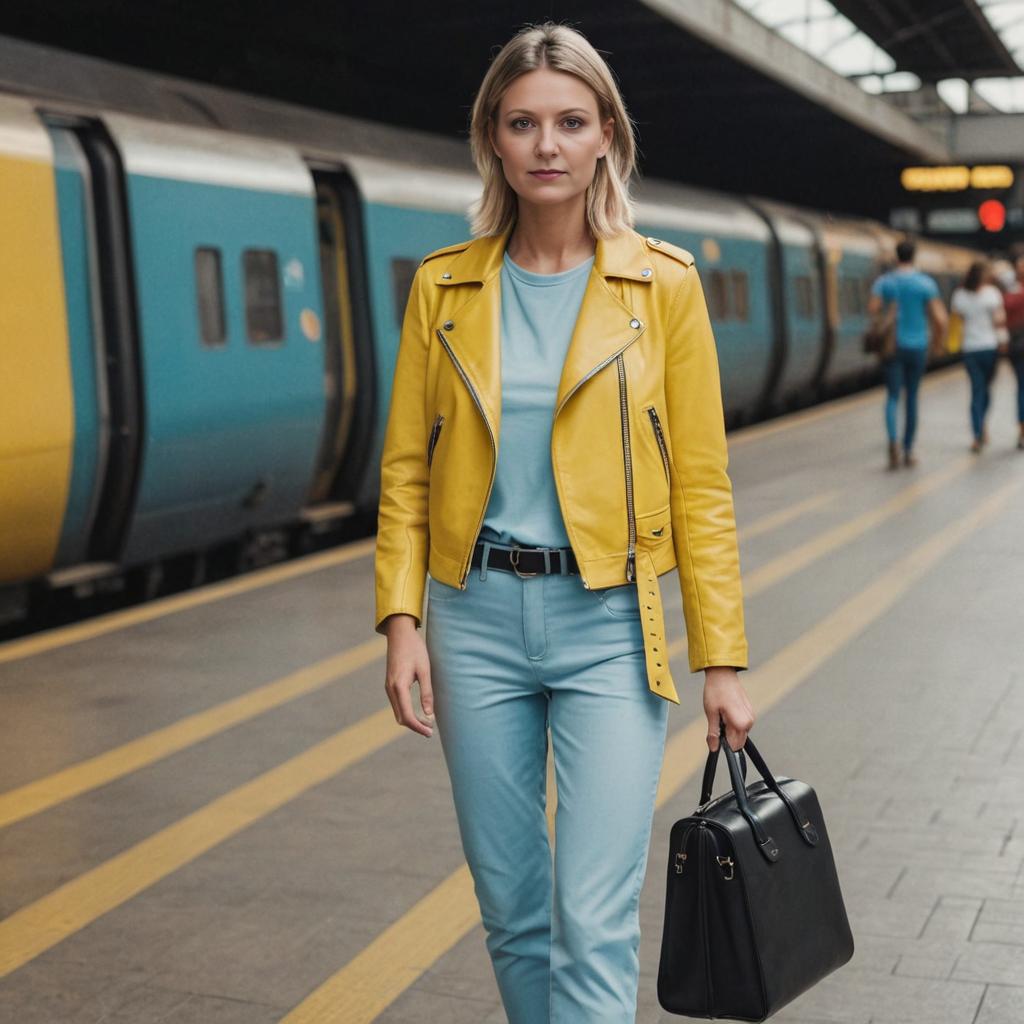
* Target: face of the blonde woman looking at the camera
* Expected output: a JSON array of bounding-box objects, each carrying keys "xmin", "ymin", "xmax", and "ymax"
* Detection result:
[{"xmin": 488, "ymin": 68, "xmax": 613, "ymax": 215}]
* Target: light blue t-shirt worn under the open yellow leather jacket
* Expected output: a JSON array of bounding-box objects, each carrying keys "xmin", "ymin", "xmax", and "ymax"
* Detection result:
[{"xmin": 480, "ymin": 247, "xmax": 594, "ymax": 548}]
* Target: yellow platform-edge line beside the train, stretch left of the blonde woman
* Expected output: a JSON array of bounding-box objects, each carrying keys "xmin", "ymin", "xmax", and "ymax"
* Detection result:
[{"xmin": 0, "ymin": 537, "xmax": 377, "ymax": 665}]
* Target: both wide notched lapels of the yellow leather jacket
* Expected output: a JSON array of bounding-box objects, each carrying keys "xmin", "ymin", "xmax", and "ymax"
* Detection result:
[{"xmin": 433, "ymin": 228, "xmax": 652, "ymax": 442}]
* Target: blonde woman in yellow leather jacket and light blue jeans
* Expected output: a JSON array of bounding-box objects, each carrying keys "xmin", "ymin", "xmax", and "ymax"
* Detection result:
[{"xmin": 375, "ymin": 23, "xmax": 754, "ymax": 1024}]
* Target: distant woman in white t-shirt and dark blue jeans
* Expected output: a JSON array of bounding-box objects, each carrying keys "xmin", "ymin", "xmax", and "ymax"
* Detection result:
[{"xmin": 949, "ymin": 260, "xmax": 1007, "ymax": 453}]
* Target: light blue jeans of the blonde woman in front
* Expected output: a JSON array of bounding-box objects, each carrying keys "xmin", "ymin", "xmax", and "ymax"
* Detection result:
[{"xmin": 425, "ymin": 568, "xmax": 669, "ymax": 1024}]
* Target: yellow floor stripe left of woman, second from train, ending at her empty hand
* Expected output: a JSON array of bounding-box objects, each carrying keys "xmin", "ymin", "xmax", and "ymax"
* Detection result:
[{"xmin": 0, "ymin": 636, "xmax": 387, "ymax": 827}]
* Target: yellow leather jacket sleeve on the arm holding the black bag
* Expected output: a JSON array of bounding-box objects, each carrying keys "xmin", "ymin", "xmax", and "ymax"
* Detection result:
[{"xmin": 665, "ymin": 264, "xmax": 748, "ymax": 672}]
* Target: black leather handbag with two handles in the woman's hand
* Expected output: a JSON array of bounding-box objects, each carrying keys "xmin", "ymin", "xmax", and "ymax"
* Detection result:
[{"xmin": 657, "ymin": 723, "xmax": 853, "ymax": 1021}]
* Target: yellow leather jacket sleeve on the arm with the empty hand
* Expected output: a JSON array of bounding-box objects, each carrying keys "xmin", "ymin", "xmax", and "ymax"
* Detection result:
[{"xmin": 374, "ymin": 264, "xmax": 430, "ymax": 634}]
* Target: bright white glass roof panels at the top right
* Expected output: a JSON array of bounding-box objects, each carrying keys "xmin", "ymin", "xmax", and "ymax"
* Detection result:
[{"xmin": 734, "ymin": 0, "xmax": 1024, "ymax": 114}]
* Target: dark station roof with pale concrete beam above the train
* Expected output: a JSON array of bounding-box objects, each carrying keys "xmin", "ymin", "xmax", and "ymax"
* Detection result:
[{"xmin": 0, "ymin": 0, "xmax": 1018, "ymax": 217}]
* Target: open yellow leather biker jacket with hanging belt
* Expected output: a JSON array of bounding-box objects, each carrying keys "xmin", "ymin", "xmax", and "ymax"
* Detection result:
[{"xmin": 375, "ymin": 230, "xmax": 748, "ymax": 703}]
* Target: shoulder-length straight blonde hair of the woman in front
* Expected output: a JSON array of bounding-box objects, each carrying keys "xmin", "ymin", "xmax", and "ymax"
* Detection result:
[{"xmin": 469, "ymin": 22, "xmax": 636, "ymax": 239}]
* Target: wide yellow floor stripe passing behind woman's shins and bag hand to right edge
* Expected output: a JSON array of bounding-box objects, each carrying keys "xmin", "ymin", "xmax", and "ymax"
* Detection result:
[{"xmin": 281, "ymin": 481, "xmax": 1020, "ymax": 1024}]
